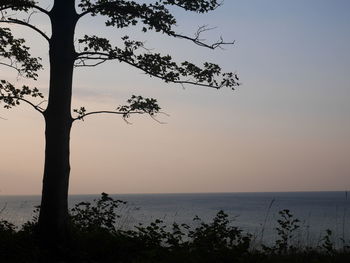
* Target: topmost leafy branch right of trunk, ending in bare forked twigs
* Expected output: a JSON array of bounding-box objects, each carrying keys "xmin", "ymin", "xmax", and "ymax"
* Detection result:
[{"xmin": 79, "ymin": 0, "xmax": 234, "ymax": 49}]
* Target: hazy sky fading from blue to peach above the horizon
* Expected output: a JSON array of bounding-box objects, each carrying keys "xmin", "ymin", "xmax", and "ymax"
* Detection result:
[{"xmin": 0, "ymin": 0, "xmax": 350, "ymax": 195}]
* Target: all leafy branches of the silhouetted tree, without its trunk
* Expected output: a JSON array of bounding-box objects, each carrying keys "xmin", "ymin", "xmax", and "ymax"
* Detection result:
[{"xmin": 0, "ymin": 0, "xmax": 240, "ymax": 119}]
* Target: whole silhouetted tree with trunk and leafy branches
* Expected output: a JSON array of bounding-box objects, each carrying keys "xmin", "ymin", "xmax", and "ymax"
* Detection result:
[{"xmin": 0, "ymin": 0, "xmax": 239, "ymax": 248}]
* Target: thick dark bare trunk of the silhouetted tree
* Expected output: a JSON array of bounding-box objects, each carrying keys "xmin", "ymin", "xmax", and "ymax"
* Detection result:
[{"xmin": 38, "ymin": 0, "xmax": 77, "ymax": 246}]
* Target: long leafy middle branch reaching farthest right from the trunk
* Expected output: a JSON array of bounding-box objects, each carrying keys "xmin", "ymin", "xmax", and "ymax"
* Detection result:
[{"xmin": 76, "ymin": 35, "xmax": 240, "ymax": 90}]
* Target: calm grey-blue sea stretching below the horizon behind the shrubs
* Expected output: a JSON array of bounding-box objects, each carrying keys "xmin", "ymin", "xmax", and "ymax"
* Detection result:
[{"xmin": 0, "ymin": 191, "xmax": 350, "ymax": 247}]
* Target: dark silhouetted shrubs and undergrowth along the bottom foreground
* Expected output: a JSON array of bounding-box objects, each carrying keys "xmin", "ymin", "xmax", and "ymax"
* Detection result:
[{"xmin": 0, "ymin": 193, "xmax": 350, "ymax": 263}]
